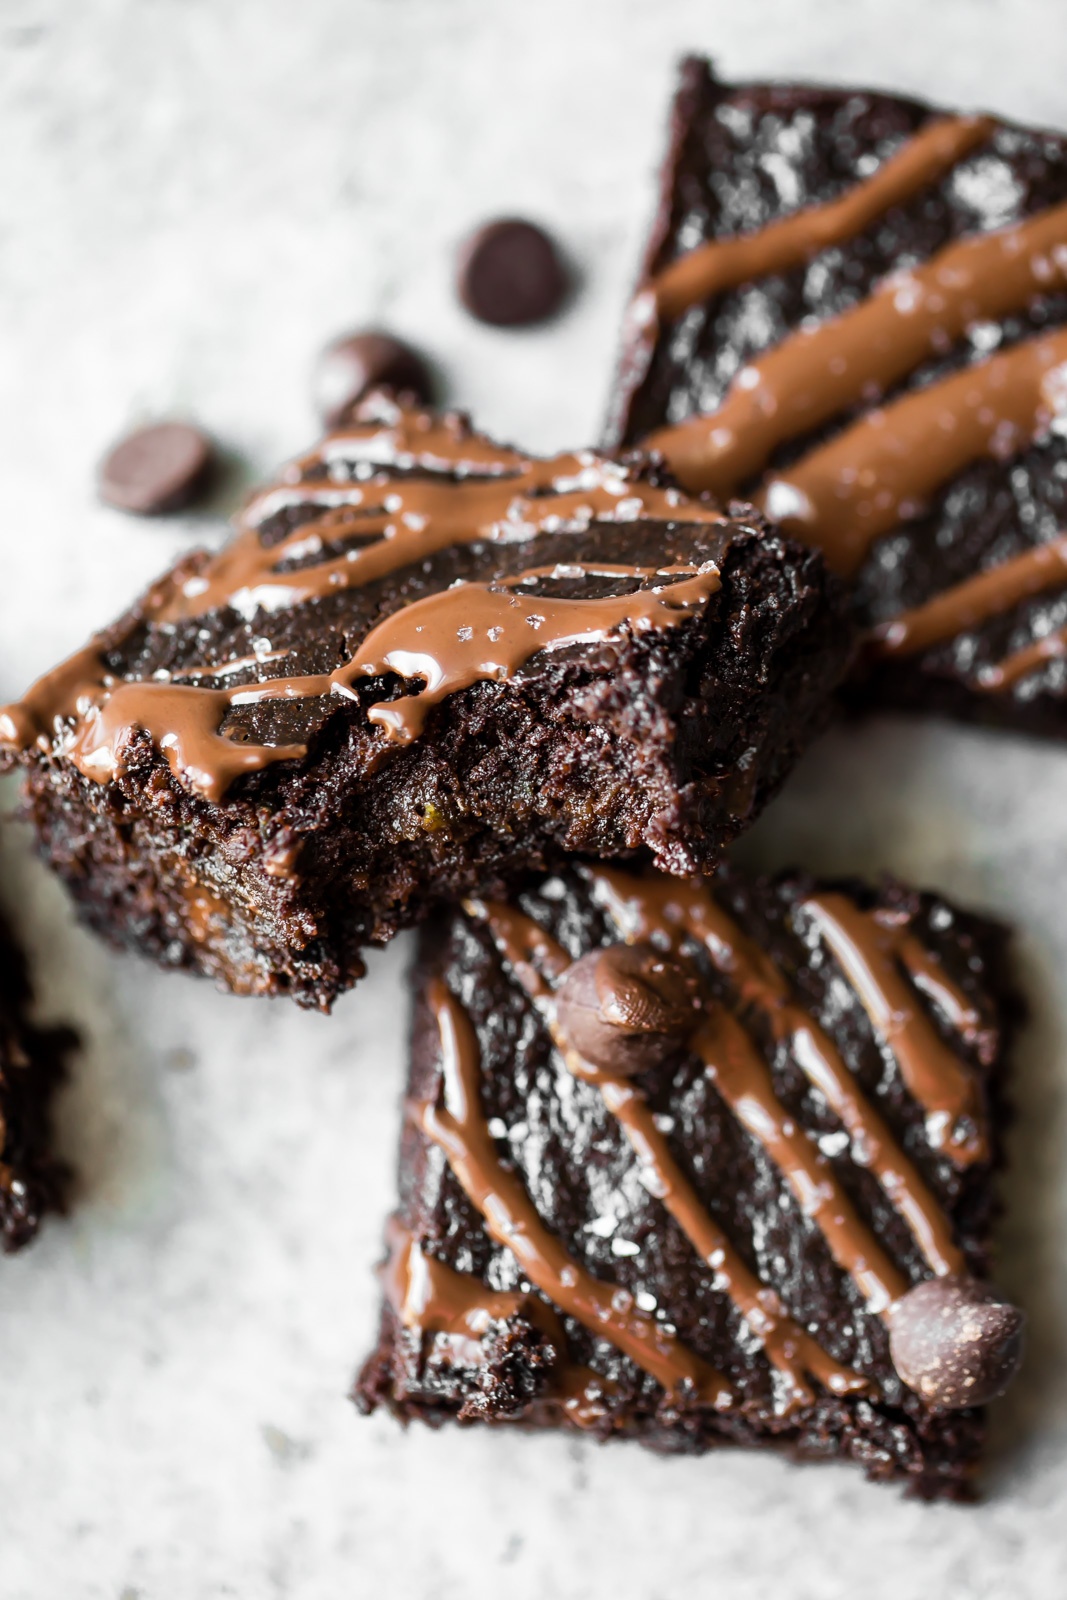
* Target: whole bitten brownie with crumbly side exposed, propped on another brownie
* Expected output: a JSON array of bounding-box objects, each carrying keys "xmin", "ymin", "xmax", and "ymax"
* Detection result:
[{"xmin": 0, "ymin": 397, "xmax": 851, "ymax": 1008}]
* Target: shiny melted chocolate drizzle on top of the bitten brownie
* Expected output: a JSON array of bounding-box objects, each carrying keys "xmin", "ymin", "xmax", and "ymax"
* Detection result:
[{"xmin": 0, "ymin": 398, "xmax": 723, "ymax": 802}]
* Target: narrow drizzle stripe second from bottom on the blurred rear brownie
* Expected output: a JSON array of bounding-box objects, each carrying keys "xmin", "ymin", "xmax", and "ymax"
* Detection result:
[{"xmin": 867, "ymin": 534, "xmax": 1067, "ymax": 656}]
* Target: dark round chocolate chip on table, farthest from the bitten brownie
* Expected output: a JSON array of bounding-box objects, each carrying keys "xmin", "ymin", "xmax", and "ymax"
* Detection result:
[{"xmin": 458, "ymin": 218, "xmax": 568, "ymax": 328}]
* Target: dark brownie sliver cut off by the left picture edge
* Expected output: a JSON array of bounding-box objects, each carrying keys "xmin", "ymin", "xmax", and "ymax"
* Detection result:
[{"xmin": 0, "ymin": 876, "xmax": 74, "ymax": 1251}]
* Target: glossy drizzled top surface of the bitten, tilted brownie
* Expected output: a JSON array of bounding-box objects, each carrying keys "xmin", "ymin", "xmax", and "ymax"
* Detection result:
[{"xmin": 0, "ymin": 397, "xmax": 758, "ymax": 802}]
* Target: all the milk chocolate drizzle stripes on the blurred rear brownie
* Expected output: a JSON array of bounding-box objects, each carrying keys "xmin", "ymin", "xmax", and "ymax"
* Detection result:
[{"xmin": 632, "ymin": 104, "xmax": 1067, "ymax": 693}]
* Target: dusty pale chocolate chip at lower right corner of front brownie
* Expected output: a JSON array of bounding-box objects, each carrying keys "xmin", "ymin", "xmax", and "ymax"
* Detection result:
[{"xmin": 889, "ymin": 1277, "xmax": 1025, "ymax": 1410}]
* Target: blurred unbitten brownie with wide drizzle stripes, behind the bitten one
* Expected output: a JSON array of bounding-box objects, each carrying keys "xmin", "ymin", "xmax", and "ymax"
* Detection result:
[{"xmin": 608, "ymin": 59, "xmax": 1067, "ymax": 736}]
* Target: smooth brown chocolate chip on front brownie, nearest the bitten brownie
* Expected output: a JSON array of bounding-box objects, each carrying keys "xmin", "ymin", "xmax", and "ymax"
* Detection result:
[{"xmin": 555, "ymin": 944, "xmax": 701, "ymax": 1074}]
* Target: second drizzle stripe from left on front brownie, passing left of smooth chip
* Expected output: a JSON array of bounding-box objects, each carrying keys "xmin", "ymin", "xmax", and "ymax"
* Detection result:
[{"xmin": 467, "ymin": 901, "xmax": 867, "ymax": 1408}]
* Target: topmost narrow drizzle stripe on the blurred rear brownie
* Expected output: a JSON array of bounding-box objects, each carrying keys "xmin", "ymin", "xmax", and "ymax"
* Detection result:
[{"xmin": 651, "ymin": 117, "xmax": 997, "ymax": 317}]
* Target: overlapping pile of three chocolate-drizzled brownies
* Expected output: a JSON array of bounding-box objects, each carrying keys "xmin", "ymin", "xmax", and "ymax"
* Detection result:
[{"xmin": 0, "ymin": 61, "xmax": 1043, "ymax": 1498}]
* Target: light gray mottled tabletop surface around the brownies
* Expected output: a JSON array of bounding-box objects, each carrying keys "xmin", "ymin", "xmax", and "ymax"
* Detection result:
[{"xmin": 0, "ymin": 0, "xmax": 1067, "ymax": 1600}]
